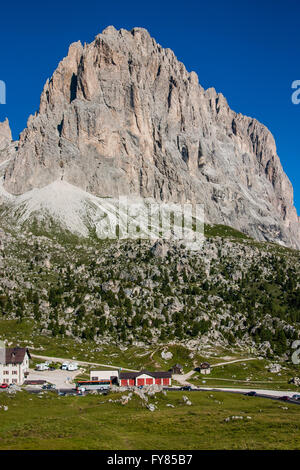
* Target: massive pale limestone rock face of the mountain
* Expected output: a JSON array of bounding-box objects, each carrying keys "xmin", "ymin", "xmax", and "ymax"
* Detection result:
[{"xmin": 0, "ymin": 26, "xmax": 300, "ymax": 248}]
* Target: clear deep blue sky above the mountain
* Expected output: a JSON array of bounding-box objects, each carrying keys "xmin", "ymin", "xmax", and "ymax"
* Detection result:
[{"xmin": 0, "ymin": 0, "xmax": 300, "ymax": 214}]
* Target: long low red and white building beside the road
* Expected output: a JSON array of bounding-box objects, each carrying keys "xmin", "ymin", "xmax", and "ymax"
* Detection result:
[{"xmin": 119, "ymin": 370, "xmax": 172, "ymax": 387}]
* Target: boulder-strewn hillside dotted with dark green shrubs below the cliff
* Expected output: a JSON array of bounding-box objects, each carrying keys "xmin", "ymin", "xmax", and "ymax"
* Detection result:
[{"xmin": 0, "ymin": 218, "xmax": 300, "ymax": 357}]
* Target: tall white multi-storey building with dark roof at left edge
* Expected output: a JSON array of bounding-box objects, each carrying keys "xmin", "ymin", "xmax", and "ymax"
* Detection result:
[{"xmin": 0, "ymin": 348, "xmax": 31, "ymax": 385}]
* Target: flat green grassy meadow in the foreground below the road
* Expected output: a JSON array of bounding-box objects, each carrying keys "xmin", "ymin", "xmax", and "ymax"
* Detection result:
[{"xmin": 0, "ymin": 392, "xmax": 300, "ymax": 450}]
